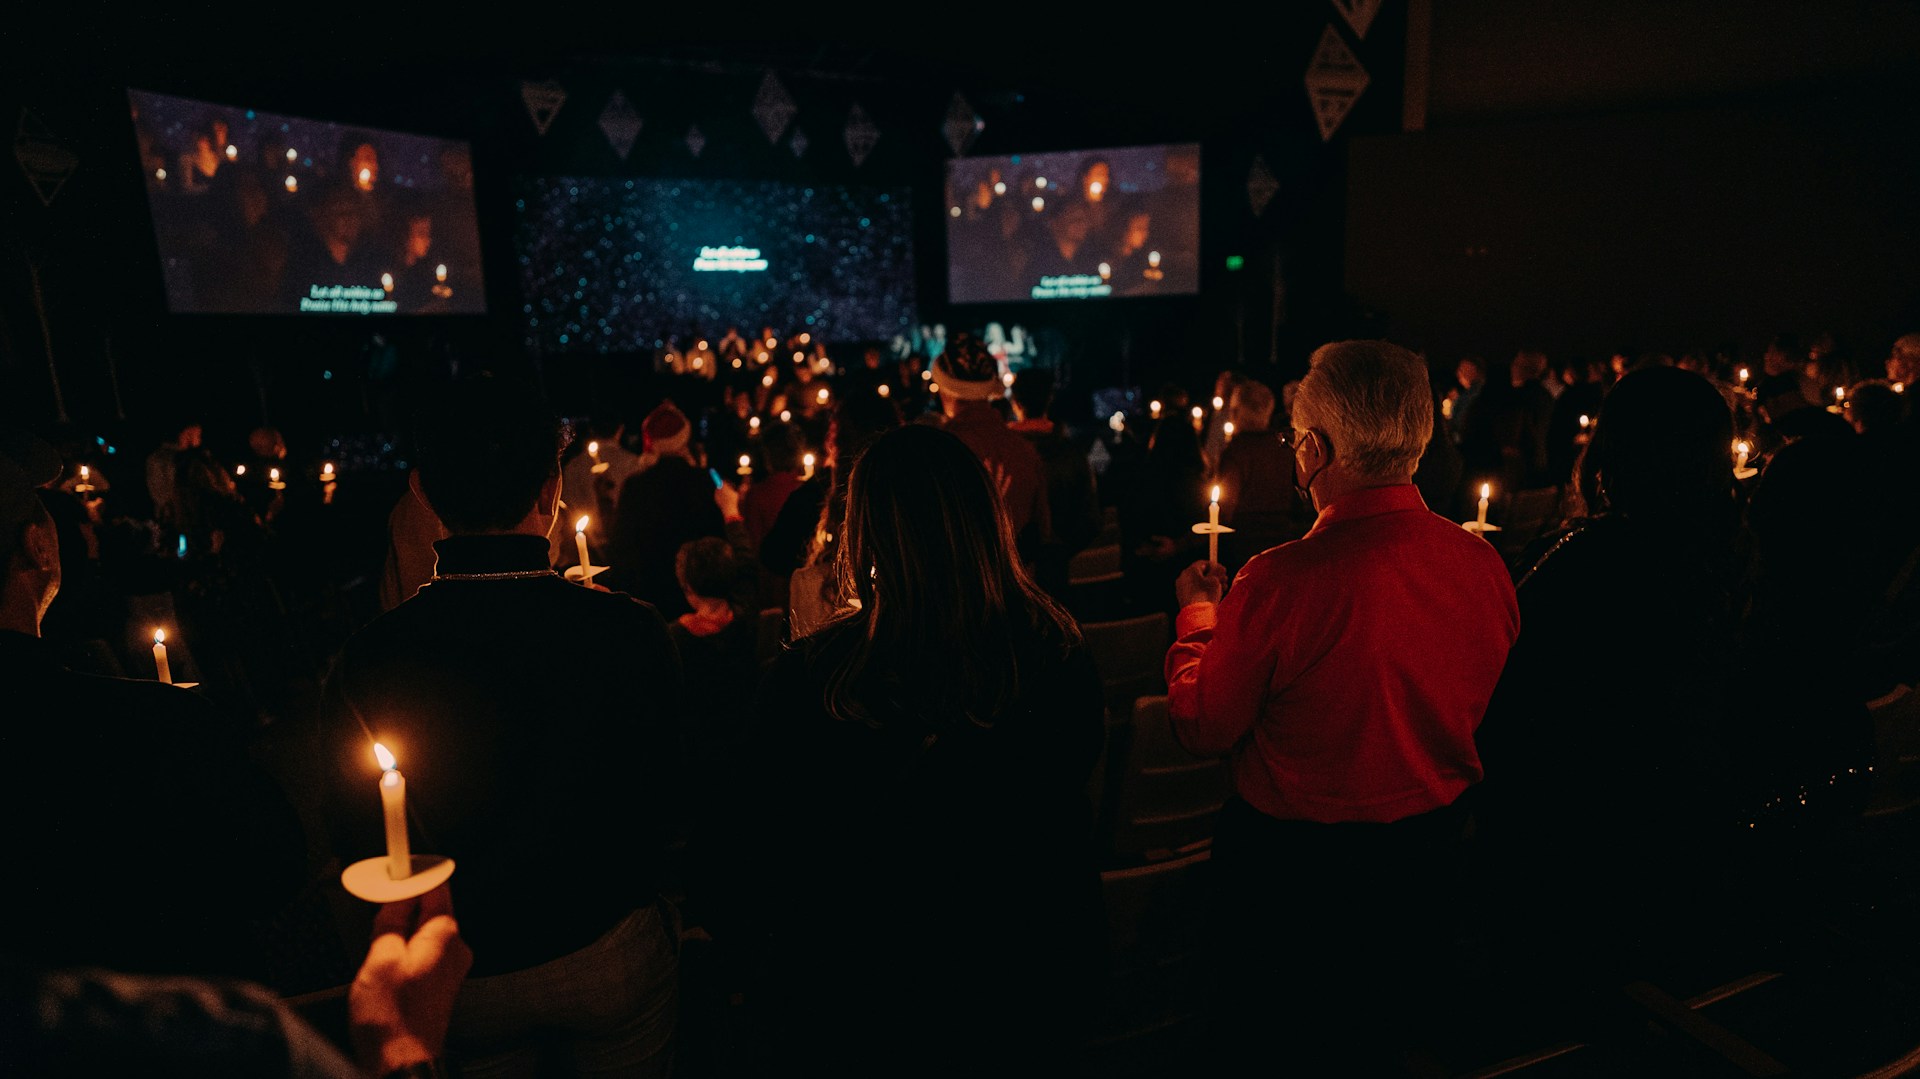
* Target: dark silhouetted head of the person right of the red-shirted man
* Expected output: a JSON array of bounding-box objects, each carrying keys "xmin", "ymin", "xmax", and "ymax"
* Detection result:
[{"xmin": 1578, "ymin": 367, "xmax": 1734, "ymax": 522}]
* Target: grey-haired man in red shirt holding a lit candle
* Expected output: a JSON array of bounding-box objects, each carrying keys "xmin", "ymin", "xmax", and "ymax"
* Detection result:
[{"xmin": 1167, "ymin": 342, "xmax": 1519, "ymax": 1073}]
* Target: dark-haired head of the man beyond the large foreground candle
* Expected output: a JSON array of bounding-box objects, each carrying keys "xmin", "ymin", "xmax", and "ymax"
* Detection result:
[{"xmin": 419, "ymin": 378, "xmax": 566, "ymax": 534}]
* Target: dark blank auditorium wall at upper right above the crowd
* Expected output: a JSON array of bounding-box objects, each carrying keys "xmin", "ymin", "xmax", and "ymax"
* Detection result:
[{"xmin": 1344, "ymin": 0, "xmax": 1920, "ymax": 361}]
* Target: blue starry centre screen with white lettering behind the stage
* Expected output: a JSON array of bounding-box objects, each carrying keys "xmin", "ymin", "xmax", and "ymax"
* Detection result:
[{"xmin": 515, "ymin": 177, "xmax": 916, "ymax": 355}]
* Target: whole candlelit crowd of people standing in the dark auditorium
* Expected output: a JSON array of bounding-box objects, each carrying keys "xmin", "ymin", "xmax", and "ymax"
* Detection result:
[{"xmin": 0, "ymin": 322, "xmax": 1920, "ymax": 1077}]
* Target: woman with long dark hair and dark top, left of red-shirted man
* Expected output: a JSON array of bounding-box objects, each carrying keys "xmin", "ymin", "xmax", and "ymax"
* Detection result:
[{"xmin": 714, "ymin": 424, "xmax": 1102, "ymax": 1075}]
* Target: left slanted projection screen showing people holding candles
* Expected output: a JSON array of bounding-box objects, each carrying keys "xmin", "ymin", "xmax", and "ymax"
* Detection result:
[{"xmin": 127, "ymin": 90, "xmax": 486, "ymax": 315}]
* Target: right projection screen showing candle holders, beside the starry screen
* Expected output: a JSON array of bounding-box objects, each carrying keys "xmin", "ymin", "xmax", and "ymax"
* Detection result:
[{"xmin": 947, "ymin": 142, "xmax": 1200, "ymax": 303}]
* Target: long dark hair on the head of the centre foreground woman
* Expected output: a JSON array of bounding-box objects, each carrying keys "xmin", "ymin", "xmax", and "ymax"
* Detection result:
[{"xmin": 829, "ymin": 424, "xmax": 1079, "ymax": 728}]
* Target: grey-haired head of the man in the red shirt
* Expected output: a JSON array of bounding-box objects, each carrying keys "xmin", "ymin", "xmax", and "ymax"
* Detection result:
[{"xmin": 1292, "ymin": 340, "xmax": 1434, "ymax": 482}]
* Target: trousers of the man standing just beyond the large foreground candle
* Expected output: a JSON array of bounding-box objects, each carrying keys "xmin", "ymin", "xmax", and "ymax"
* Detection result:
[{"xmin": 447, "ymin": 900, "xmax": 680, "ymax": 1079}]
